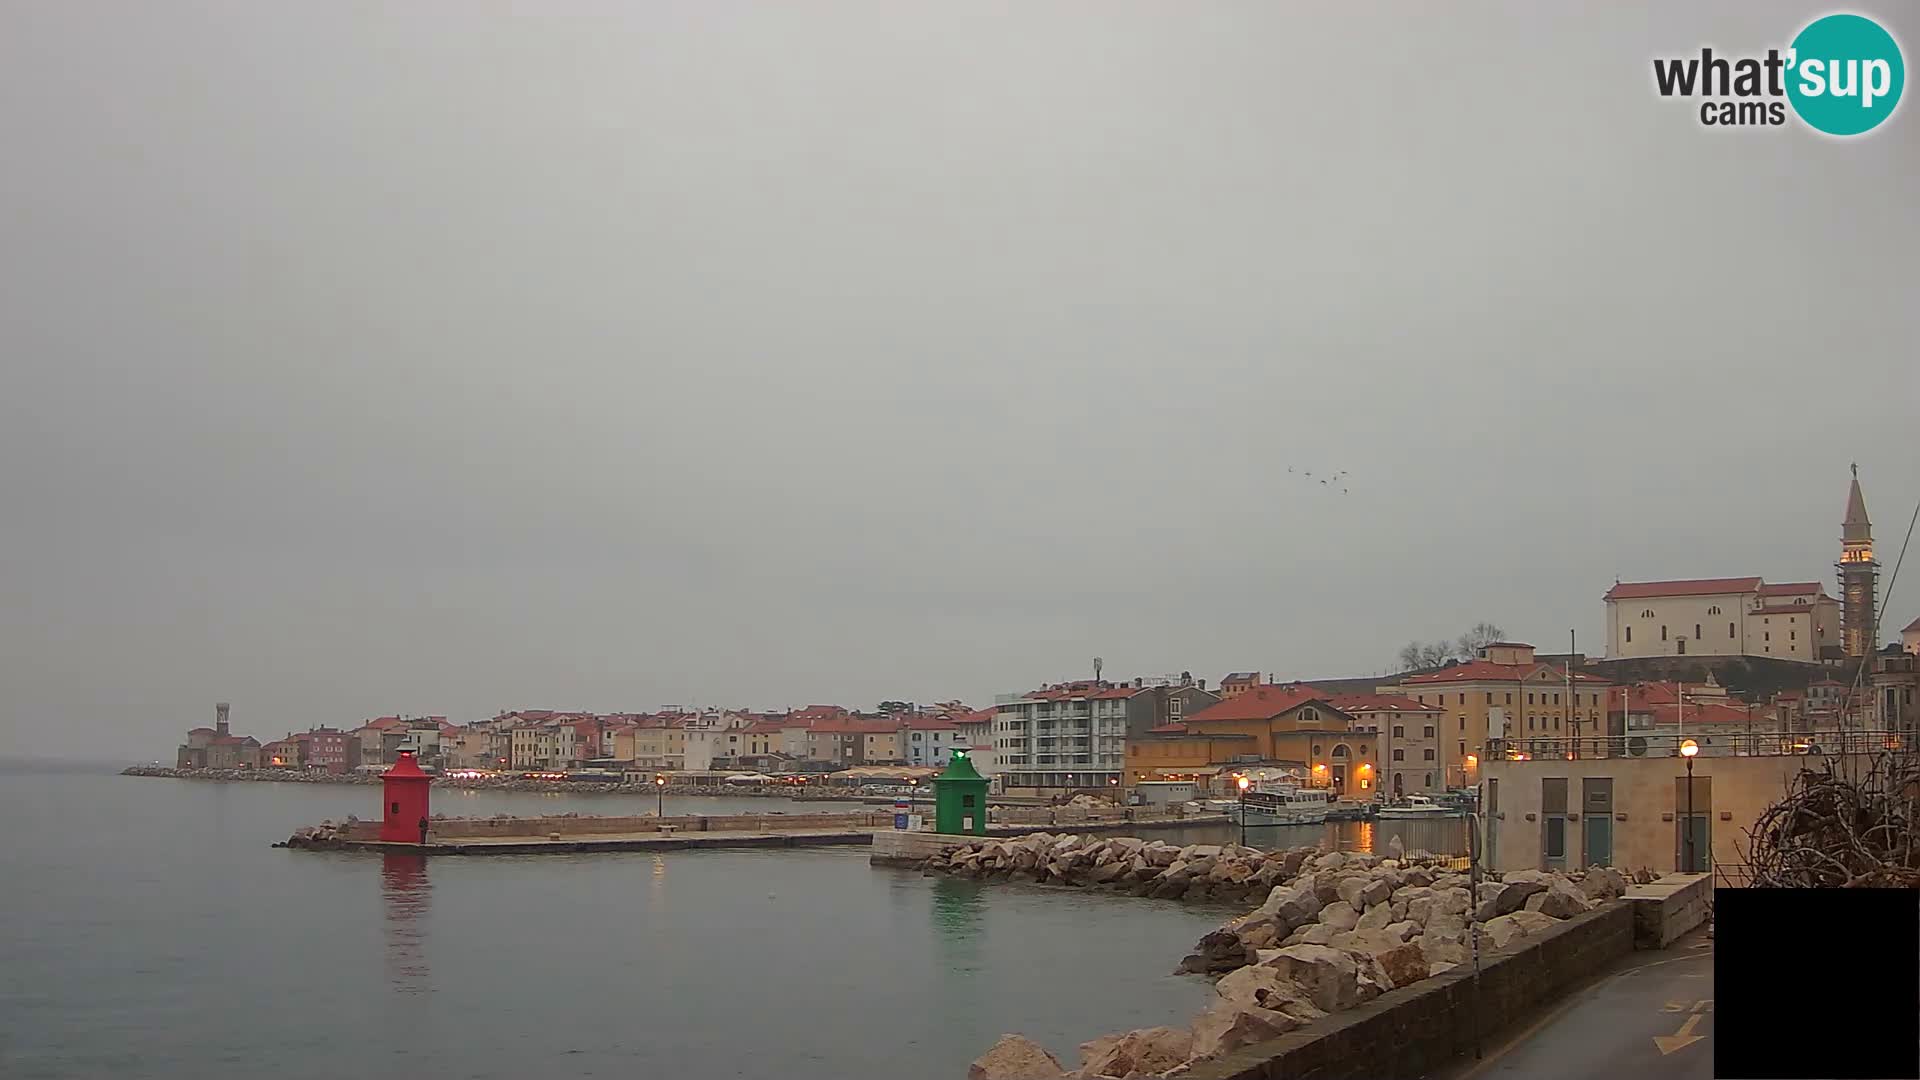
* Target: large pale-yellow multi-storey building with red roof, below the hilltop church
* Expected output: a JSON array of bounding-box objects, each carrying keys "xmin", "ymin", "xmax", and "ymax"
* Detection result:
[{"xmin": 1380, "ymin": 642, "xmax": 1611, "ymax": 790}]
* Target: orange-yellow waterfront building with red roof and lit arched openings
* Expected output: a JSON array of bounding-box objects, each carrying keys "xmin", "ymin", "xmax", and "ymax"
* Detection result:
[{"xmin": 1127, "ymin": 686, "xmax": 1379, "ymax": 799}]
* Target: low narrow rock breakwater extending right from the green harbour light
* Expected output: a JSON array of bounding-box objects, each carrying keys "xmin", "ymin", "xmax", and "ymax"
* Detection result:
[{"xmin": 924, "ymin": 832, "xmax": 1317, "ymax": 903}]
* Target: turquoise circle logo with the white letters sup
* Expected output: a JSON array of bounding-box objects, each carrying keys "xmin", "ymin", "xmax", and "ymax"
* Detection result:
[{"xmin": 1788, "ymin": 15, "xmax": 1907, "ymax": 135}]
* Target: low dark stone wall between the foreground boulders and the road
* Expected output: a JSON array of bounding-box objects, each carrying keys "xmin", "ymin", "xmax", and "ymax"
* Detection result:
[{"xmin": 1187, "ymin": 901, "xmax": 1634, "ymax": 1080}]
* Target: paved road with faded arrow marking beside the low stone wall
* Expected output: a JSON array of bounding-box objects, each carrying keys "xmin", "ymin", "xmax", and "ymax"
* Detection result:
[{"xmin": 1440, "ymin": 930, "xmax": 1713, "ymax": 1080}]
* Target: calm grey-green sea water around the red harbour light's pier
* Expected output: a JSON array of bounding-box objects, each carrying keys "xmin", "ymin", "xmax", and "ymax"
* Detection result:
[{"xmin": 0, "ymin": 765, "xmax": 1466, "ymax": 1080}]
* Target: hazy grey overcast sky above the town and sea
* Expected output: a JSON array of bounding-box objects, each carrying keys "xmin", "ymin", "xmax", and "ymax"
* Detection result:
[{"xmin": 0, "ymin": 0, "xmax": 1920, "ymax": 757}]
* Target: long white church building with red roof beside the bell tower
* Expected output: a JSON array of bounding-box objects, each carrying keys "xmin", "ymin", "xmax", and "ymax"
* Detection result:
[{"xmin": 1603, "ymin": 577, "xmax": 1839, "ymax": 661}]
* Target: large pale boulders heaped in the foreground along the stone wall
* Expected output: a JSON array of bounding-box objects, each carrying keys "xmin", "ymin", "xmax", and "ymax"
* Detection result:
[{"xmin": 968, "ymin": 851, "xmax": 1626, "ymax": 1080}]
